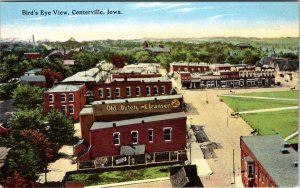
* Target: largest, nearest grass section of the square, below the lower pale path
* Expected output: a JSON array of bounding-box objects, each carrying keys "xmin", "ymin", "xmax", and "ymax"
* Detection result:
[{"xmin": 241, "ymin": 110, "xmax": 298, "ymax": 138}]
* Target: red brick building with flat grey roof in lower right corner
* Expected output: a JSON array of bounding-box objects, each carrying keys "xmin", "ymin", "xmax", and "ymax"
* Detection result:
[{"xmin": 240, "ymin": 135, "xmax": 298, "ymax": 187}]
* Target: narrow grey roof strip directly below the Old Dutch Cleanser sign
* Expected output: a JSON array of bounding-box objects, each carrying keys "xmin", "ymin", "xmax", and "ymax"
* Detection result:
[{"xmin": 91, "ymin": 112, "xmax": 186, "ymax": 130}]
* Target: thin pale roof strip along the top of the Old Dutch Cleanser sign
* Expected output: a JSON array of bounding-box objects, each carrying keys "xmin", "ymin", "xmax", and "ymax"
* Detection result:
[{"xmin": 92, "ymin": 95, "xmax": 182, "ymax": 105}]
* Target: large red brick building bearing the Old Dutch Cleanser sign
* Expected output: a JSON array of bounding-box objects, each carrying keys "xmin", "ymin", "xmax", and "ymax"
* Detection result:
[{"xmin": 74, "ymin": 95, "xmax": 186, "ymax": 161}]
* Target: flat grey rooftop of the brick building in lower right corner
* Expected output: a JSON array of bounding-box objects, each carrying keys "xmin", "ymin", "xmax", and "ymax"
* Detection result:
[{"xmin": 241, "ymin": 135, "xmax": 298, "ymax": 187}]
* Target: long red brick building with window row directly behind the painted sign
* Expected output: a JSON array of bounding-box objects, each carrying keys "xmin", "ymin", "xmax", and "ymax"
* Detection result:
[{"xmin": 93, "ymin": 77, "xmax": 172, "ymax": 100}]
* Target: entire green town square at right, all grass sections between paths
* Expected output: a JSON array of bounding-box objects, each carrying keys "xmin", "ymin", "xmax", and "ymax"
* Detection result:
[{"xmin": 221, "ymin": 91, "xmax": 298, "ymax": 143}]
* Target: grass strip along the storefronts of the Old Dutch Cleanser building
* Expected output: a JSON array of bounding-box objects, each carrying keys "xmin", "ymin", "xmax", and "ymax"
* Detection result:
[{"xmin": 67, "ymin": 165, "xmax": 171, "ymax": 186}]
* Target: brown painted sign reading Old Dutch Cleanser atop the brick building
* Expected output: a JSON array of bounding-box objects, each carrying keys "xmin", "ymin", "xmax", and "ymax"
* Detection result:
[{"xmin": 93, "ymin": 95, "xmax": 182, "ymax": 116}]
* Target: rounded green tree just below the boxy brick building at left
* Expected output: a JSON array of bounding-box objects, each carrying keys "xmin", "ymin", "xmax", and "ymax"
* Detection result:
[{"xmin": 46, "ymin": 110, "xmax": 75, "ymax": 149}]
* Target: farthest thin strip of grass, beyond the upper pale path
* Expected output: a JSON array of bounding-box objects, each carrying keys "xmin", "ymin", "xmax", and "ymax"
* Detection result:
[{"xmin": 238, "ymin": 90, "xmax": 298, "ymax": 99}]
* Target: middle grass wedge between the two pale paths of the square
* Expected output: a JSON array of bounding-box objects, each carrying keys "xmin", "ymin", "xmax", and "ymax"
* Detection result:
[{"xmin": 221, "ymin": 96, "xmax": 298, "ymax": 112}]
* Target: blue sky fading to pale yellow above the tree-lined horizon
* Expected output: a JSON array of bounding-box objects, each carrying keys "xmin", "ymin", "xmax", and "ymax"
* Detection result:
[{"xmin": 0, "ymin": 2, "xmax": 299, "ymax": 41}]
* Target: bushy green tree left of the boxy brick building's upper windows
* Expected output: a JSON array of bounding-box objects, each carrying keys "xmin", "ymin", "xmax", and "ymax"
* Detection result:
[{"xmin": 13, "ymin": 84, "xmax": 44, "ymax": 109}]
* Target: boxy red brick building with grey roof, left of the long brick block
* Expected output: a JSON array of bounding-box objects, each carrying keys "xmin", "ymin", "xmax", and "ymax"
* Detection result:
[{"xmin": 44, "ymin": 84, "xmax": 86, "ymax": 120}]
